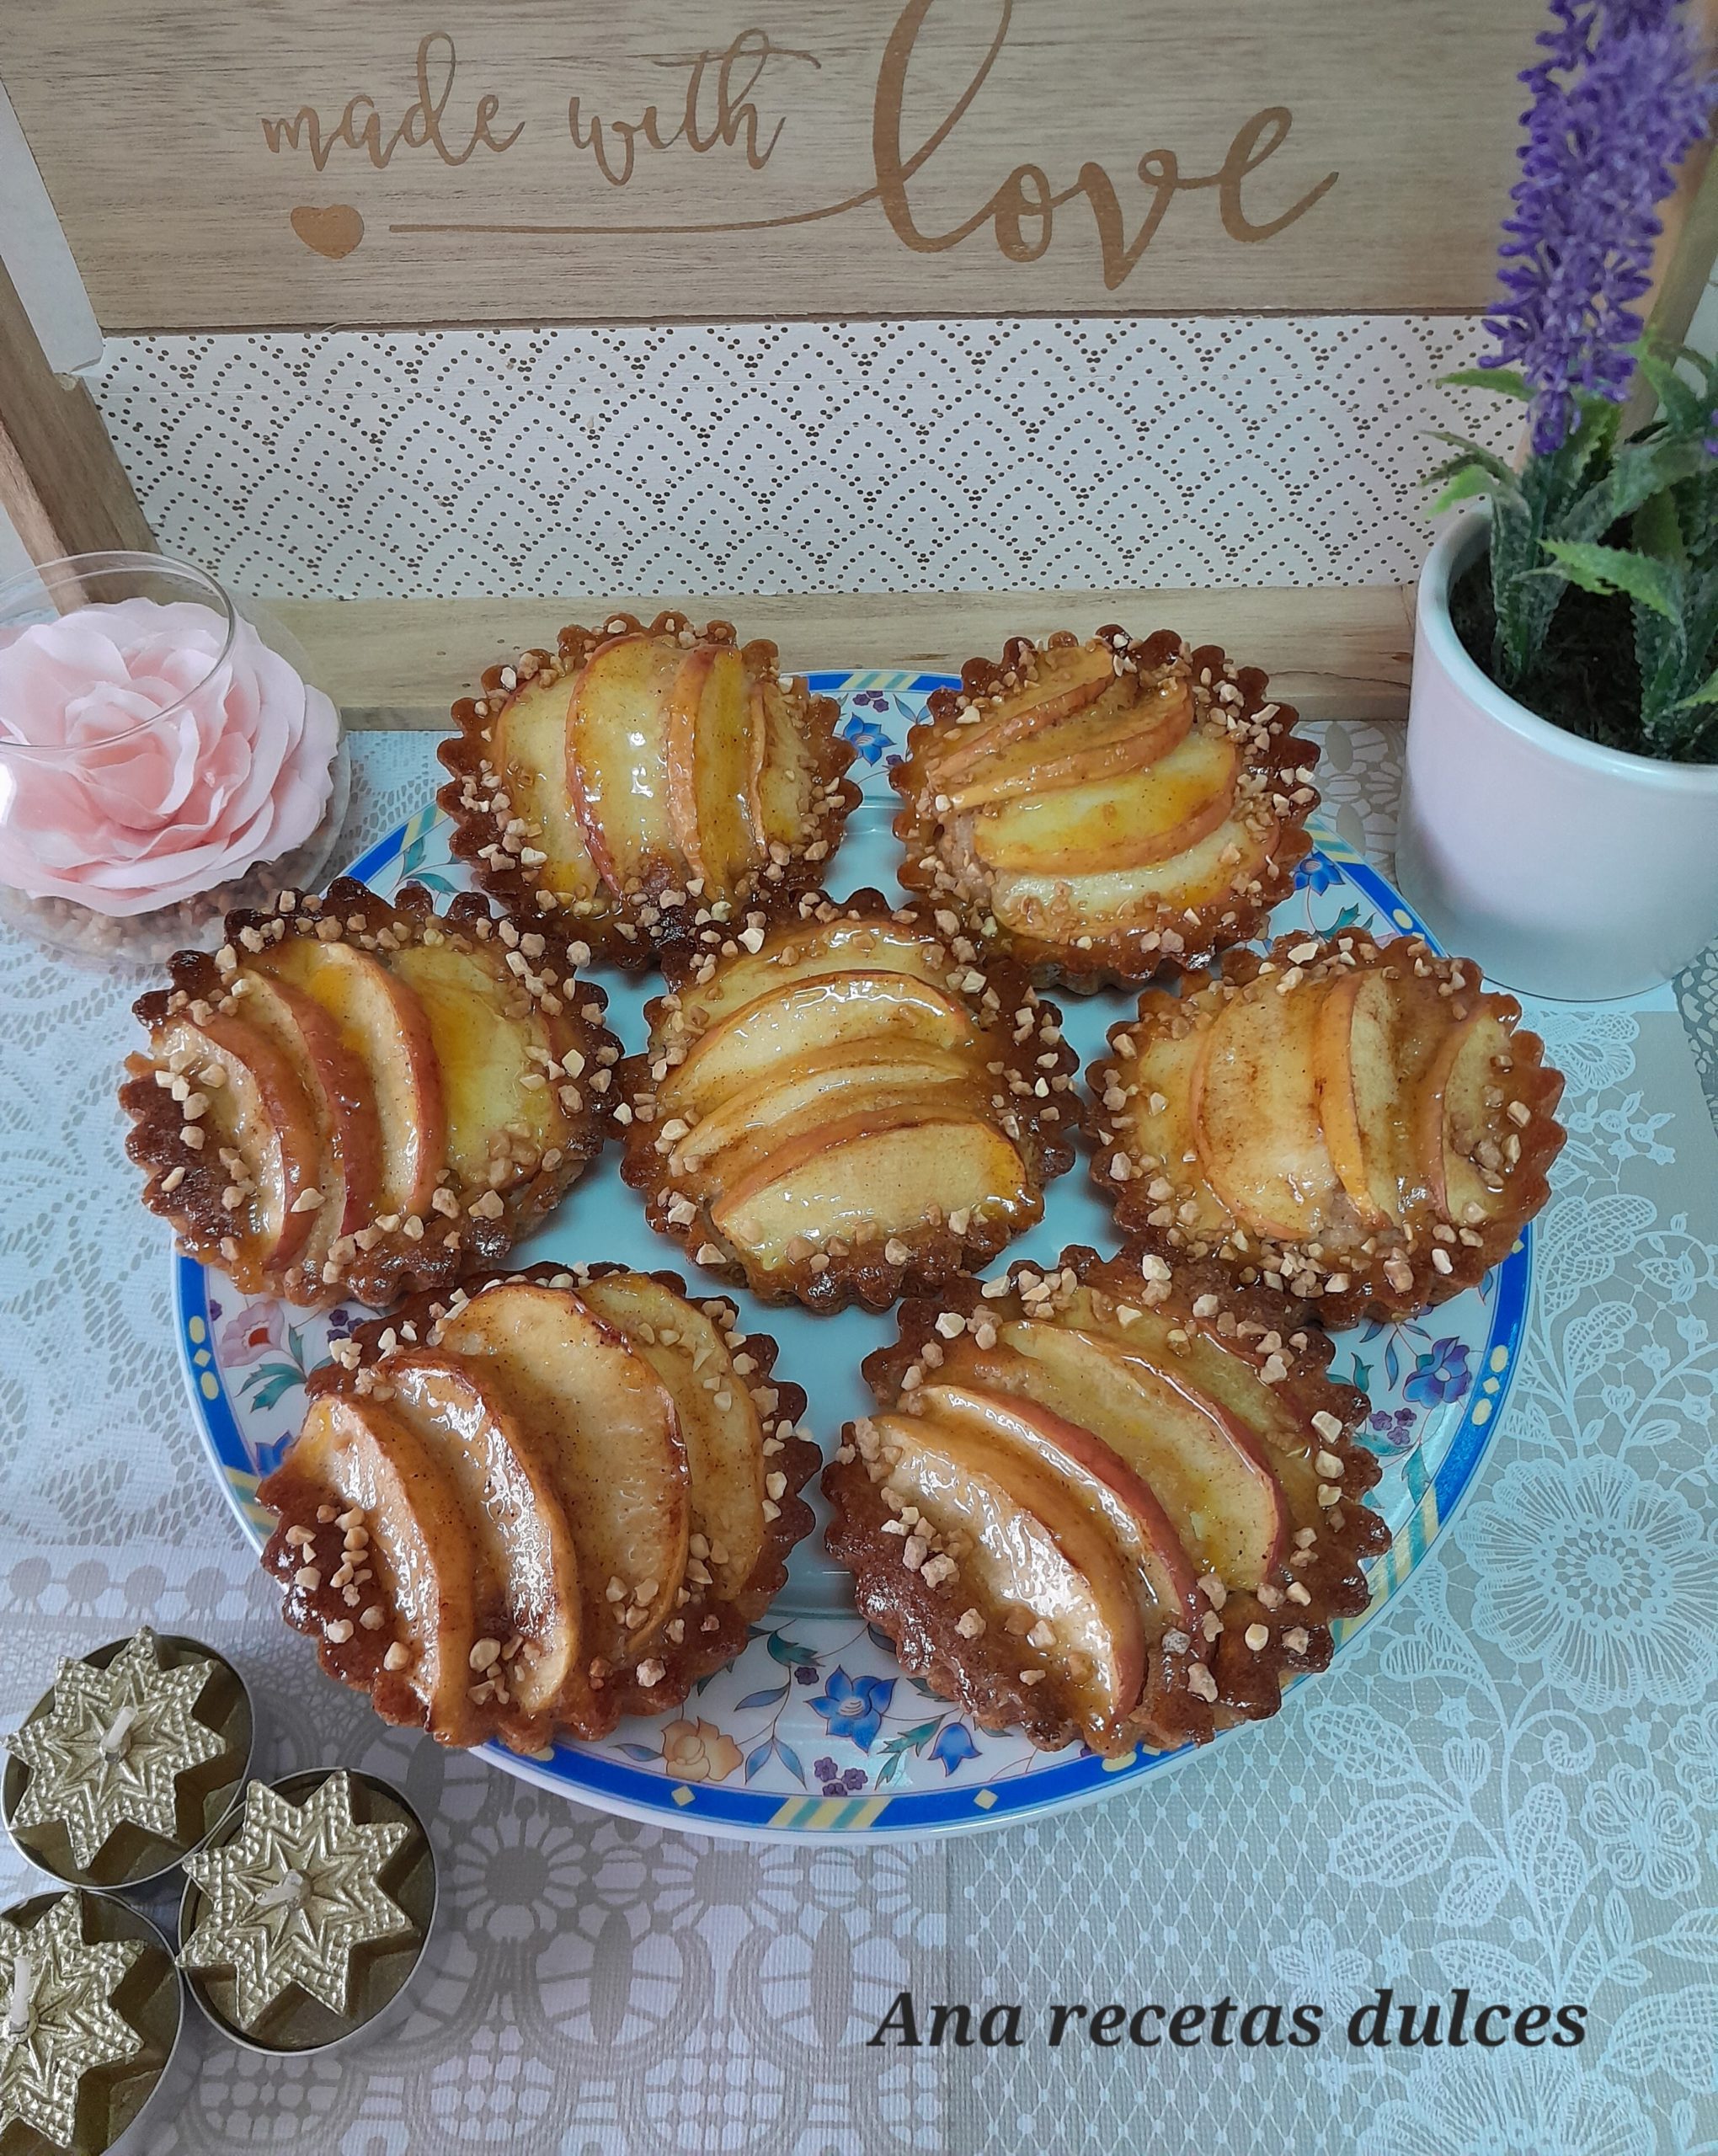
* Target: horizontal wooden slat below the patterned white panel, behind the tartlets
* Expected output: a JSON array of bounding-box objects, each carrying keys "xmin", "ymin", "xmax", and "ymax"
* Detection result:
[{"xmin": 267, "ymin": 584, "xmax": 1414, "ymax": 727}]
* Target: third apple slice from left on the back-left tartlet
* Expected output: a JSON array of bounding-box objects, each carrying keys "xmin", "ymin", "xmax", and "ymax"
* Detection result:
[{"xmin": 668, "ymin": 644, "xmax": 763, "ymax": 899}]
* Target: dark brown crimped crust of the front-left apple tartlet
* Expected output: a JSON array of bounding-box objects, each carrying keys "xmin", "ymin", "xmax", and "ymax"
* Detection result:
[{"xmin": 259, "ymin": 1263, "xmax": 819, "ymax": 1751}]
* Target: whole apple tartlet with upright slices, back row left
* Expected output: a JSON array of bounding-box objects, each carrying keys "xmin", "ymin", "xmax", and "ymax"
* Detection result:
[{"xmin": 438, "ymin": 612, "xmax": 860, "ymax": 966}]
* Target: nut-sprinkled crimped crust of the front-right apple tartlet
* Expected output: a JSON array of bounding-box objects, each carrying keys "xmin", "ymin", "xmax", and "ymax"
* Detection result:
[{"xmin": 824, "ymin": 1244, "xmax": 1388, "ymax": 1755}]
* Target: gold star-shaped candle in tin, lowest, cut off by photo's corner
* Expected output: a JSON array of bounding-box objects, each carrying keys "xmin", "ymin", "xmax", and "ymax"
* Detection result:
[{"xmin": 0, "ymin": 1886, "xmax": 184, "ymax": 2156}]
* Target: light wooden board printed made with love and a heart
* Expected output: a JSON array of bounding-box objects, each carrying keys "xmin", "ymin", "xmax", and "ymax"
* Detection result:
[{"xmin": 0, "ymin": 0, "xmax": 1545, "ymax": 332}]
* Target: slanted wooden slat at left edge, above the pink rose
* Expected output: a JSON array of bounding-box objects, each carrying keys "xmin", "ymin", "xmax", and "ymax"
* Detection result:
[{"xmin": 0, "ymin": 265, "xmax": 155, "ymax": 561}]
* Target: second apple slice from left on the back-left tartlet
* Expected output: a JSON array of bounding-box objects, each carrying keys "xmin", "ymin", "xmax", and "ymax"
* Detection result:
[{"xmin": 567, "ymin": 636, "xmax": 686, "ymax": 890}]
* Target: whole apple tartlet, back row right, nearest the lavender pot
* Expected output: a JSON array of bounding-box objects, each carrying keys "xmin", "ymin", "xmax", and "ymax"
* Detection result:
[{"xmin": 890, "ymin": 627, "xmax": 1319, "ymax": 990}]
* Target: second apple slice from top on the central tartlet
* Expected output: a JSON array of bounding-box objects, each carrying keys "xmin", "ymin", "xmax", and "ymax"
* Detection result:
[{"xmin": 658, "ymin": 973, "xmax": 976, "ymax": 1113}]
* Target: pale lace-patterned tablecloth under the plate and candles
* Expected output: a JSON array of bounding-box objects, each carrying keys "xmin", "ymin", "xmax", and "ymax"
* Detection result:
[{"xmin": 0, "ymin": 724, "xmax": 1718, "ymax": 2156}]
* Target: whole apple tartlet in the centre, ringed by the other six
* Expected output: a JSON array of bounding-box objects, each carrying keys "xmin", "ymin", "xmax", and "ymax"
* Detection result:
[{"xmin": 614, "ymin": 890, "xmax": 1080, "ymax": 1310}]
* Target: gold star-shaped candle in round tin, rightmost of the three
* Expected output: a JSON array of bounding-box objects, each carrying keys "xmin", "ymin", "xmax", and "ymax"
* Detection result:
[{"xmin": 179, "ymin": 1768, "xmax": 435, "ymax": 2052}]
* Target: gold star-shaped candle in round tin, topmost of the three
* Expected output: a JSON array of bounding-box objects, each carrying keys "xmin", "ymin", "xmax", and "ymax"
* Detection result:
[{"xmin": 0, "ymin": 1628, "xmax": 254, "ymax": 1893}]
